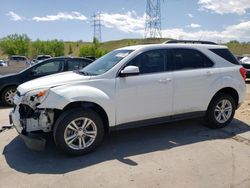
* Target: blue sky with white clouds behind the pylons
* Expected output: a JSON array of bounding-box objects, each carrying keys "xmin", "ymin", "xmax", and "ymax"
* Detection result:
[{"xmin": 0, "ymin": 0, "xmax": 250, "ymax": 42}]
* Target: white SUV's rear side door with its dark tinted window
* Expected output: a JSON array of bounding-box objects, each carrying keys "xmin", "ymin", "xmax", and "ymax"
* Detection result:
[{"xmin": 171, "ymin": 49, "xmax": 215, "ymax": 114}]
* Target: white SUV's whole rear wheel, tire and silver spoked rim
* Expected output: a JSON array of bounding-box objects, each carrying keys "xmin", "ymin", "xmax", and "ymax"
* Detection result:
[{"xmin": 205, "ymin": 93, "xmax": 236, "ymax": 129}]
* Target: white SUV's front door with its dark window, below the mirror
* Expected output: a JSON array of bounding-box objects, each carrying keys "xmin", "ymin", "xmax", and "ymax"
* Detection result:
[{"xmin": 116, "ymin": 50, "xmax": 173, "ymax": 125}]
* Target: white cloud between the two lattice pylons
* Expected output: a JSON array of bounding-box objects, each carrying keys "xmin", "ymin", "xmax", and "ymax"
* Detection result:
[{"xmin": 101, "ymin": 11, "xmax": 146, "ymax": 33}]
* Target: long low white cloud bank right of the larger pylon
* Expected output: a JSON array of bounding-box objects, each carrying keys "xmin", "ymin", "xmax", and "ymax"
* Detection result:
[{"xmin": 162, "ymin": 21, "xmax": 250, "ymax": 42}]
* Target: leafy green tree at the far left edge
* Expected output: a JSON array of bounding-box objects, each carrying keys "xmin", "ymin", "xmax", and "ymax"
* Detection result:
[{"xmin": 0, "ymin": 34, "xmax": 30, "ymax": 56}]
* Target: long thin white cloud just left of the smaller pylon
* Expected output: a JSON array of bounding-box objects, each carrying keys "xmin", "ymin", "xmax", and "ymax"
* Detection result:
[{"xmin": 32, "ymin": 11, "xmax": 87, "ymax": 22}]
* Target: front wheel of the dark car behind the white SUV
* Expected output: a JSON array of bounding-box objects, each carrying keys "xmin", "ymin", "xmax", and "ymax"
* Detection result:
[{"xmin": 1, "ymin": 86, "xmax": 17, "ymax": 106}]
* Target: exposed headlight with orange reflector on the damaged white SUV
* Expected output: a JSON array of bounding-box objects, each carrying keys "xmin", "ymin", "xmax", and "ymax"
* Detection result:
[{"xmin": 23, "ymin": 88, "xmax": 49, "ymax": 103}]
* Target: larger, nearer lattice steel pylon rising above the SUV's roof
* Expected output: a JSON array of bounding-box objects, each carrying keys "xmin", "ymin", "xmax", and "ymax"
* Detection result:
[{"xmin": 144, "ymin": 0, "xmax": 162, "ymax": 38}]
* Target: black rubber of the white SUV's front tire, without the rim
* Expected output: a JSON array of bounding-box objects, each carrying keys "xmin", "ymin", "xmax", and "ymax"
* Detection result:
[{"xmin": 53, "ymin": 108, "xmax": 104, "ymax": 156}]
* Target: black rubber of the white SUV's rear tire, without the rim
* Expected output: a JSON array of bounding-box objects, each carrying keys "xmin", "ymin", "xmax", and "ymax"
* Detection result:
[{"xmin": 205, "ymin": 93, "xmax": 236, "ymax": 129}]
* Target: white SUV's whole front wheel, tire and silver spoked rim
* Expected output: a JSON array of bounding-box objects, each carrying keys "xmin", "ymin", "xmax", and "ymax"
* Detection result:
[{"xmin": 53, "ymin": 108, "xmax": 104, "ymax": 156}]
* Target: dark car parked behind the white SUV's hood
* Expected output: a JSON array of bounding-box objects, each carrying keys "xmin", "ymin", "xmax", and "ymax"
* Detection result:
[{"xmin": 0, "ymin": 57, "xmax": 93, "ymax": 105}]
